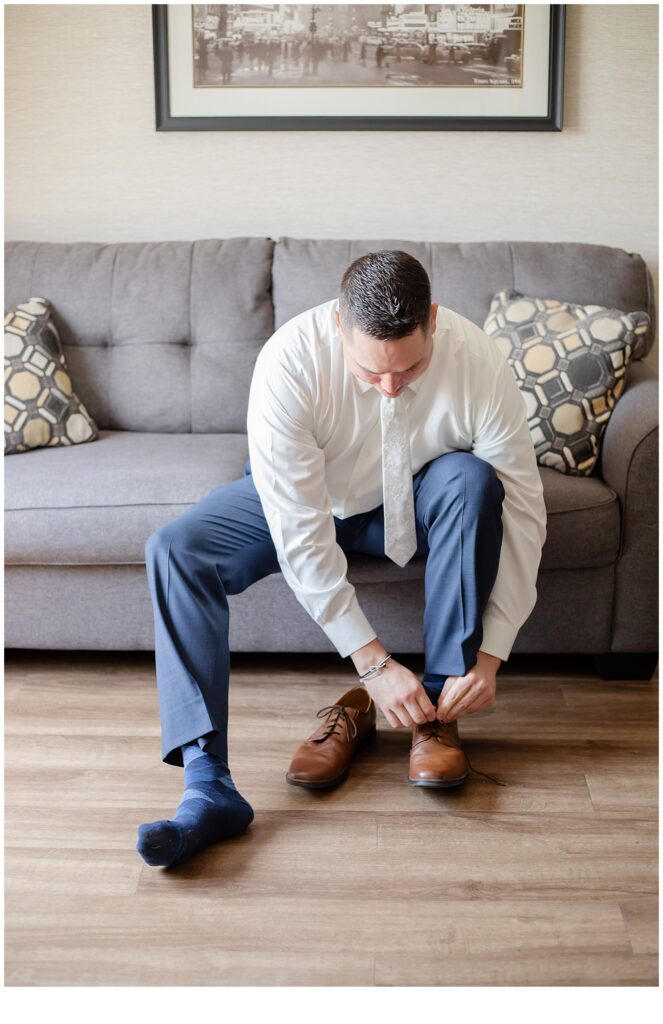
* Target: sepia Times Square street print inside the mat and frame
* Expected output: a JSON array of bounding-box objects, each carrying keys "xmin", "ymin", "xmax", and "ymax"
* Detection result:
[{"xmin": 192, "ymin": 4, "xmax": 527, "ymax": 89}]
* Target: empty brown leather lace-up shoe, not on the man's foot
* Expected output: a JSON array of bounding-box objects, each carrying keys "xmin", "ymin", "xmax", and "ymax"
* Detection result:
[{"xmin": 286, "ymin": 686, "xmax": 376, "ymax": 790}]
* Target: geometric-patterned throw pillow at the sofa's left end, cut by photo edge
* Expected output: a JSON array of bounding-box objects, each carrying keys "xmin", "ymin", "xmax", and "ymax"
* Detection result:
[{"xmin": 4, "ymin": 297, "xmax": 98, "ymax": 455}]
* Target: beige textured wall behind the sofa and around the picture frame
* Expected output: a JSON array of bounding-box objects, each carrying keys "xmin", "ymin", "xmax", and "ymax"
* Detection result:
[{"xmin": 4, "ymin": 4, "xmax": 658, "ymax": 368}]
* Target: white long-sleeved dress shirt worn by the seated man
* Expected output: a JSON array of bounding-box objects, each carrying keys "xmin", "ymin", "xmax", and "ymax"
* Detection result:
[{"xmin": 247, "ymin": 298, "xmax": 546, "ymax": 662}]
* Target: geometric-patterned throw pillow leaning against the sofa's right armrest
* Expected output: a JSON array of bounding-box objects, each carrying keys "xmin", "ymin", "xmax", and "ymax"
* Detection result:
[{"xmin": 484, "ymin": 289, "xmax": 650, "ymax": 476}]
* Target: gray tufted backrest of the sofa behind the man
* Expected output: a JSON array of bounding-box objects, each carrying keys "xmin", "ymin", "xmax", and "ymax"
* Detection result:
[{"xmin": 5, "ymin": 237, "xmax": 656, "ymax": 433}]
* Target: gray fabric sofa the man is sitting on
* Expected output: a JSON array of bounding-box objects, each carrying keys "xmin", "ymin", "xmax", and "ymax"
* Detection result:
[{"xmin": 5, "ymin": 238, "xmax": 658, "ymax": 678}]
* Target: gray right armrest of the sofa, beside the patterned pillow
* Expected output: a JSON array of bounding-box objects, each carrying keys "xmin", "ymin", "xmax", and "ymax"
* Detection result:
[{"xmin": 597, "ymin": 359, "xmax": 659, "ymax": 651}]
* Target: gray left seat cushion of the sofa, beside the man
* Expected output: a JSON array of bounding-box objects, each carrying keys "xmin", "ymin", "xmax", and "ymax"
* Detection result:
[{"xmin": 5, "ymin": 430, "xmax": 248, "ymax": 565}]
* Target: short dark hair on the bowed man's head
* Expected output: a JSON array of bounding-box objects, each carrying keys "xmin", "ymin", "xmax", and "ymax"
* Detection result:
[{"xmin": 338, "ymin": 249, "xmax": 430, "ymax": 341}]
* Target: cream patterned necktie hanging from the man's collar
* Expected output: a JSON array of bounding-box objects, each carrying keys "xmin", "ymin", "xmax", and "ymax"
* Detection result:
[{"xmin": 380, "ymin": 395, "xmax": 417, "ymax": 565}]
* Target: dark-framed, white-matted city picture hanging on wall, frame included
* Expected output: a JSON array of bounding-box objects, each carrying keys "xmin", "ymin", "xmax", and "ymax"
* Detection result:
[{"xmin": 152, "ymin": 4, "xmax": 566, "ymax": 131}]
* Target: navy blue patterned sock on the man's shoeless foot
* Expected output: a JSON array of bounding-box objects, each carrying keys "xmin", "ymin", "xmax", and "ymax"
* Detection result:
[{"xmin": 136, "ymin": 736, "xmax": 254, "ymax": 867}]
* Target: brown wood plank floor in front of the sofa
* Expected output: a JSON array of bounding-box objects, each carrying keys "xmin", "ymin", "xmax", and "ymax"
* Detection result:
[{"xmin": 5, "ymin": 650, "xmax": 658, "ymax": 986}]
